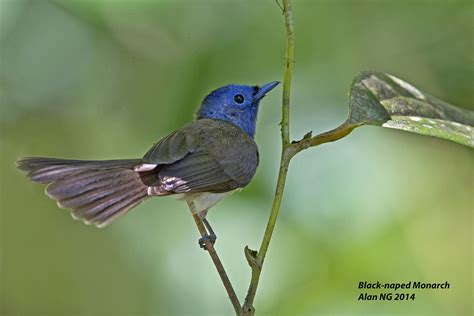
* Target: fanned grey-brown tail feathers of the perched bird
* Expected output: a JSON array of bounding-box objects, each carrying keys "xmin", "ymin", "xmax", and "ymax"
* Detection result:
[{"xmin": 17, "ymin": 157, "xmax": 148, "ymax": 227}]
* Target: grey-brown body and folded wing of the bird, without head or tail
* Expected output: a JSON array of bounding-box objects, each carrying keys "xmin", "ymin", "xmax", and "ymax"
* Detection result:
[{"xmin": 143, "ymin": 119, "xmax": 258, "ymax": 193}]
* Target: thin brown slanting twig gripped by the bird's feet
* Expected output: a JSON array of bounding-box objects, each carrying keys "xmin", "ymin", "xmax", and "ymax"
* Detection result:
[{"xmin": 187, "ymin": 201, "xmax": 242, "ymax": 315}]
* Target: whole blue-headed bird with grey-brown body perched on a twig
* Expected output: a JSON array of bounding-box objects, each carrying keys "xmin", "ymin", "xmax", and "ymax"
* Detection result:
[{"xmin": 17, "ymin": 81, "xmax": 279, "ymax": 249}]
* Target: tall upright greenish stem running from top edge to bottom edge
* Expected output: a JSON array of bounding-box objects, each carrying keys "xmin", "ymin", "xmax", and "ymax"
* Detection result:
[{"xmin": 242, "ymin": 0, "xmax": 296, "ymax": 315}]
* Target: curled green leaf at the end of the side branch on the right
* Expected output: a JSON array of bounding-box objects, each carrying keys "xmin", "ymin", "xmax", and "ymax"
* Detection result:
[{"xmin": 345, "ymin": 71, "xmax": 474, "ymax": 147}]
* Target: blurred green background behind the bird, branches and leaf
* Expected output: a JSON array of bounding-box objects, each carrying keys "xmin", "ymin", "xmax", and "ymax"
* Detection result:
[{"xmin": 0, "ymin": 0, "xmax": 474, "ymax": 316}]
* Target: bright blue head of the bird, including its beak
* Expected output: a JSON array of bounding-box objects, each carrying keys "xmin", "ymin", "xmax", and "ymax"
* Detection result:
[{"xmin": 197, "ymin": 81, "xmax": 279, "ymax": 137}]
